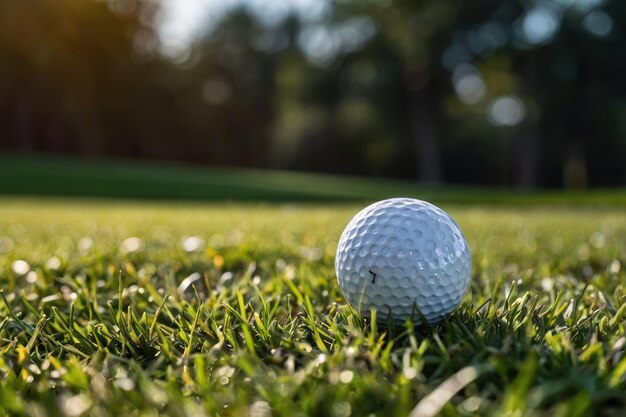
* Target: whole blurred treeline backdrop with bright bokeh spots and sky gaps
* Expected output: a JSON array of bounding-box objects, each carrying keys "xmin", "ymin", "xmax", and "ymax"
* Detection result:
[{"xmin": 0, "ymin": 0, "xmax": 626, "ymax": 188}]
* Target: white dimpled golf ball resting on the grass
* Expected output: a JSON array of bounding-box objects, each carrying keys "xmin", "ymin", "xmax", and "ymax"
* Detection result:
[{"xmin": 335, "ymin": 198, "xmax": 472, "ymax": 324}]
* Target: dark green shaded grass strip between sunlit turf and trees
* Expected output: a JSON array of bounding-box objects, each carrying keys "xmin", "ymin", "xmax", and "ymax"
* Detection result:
[{"xmin": 0, "ymin": 153, "xmax": 626, "ymax": 206}]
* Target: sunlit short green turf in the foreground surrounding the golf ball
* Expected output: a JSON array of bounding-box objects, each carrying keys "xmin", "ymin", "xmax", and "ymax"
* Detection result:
[{"xmin": 0, "ymin": 198, "xmax": 626, "ymax": 417}]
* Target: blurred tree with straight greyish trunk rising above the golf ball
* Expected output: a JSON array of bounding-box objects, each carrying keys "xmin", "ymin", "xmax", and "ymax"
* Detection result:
[{"xmin": 336, "ymin": 0, "xmax": 458, "ymax": 183}]
